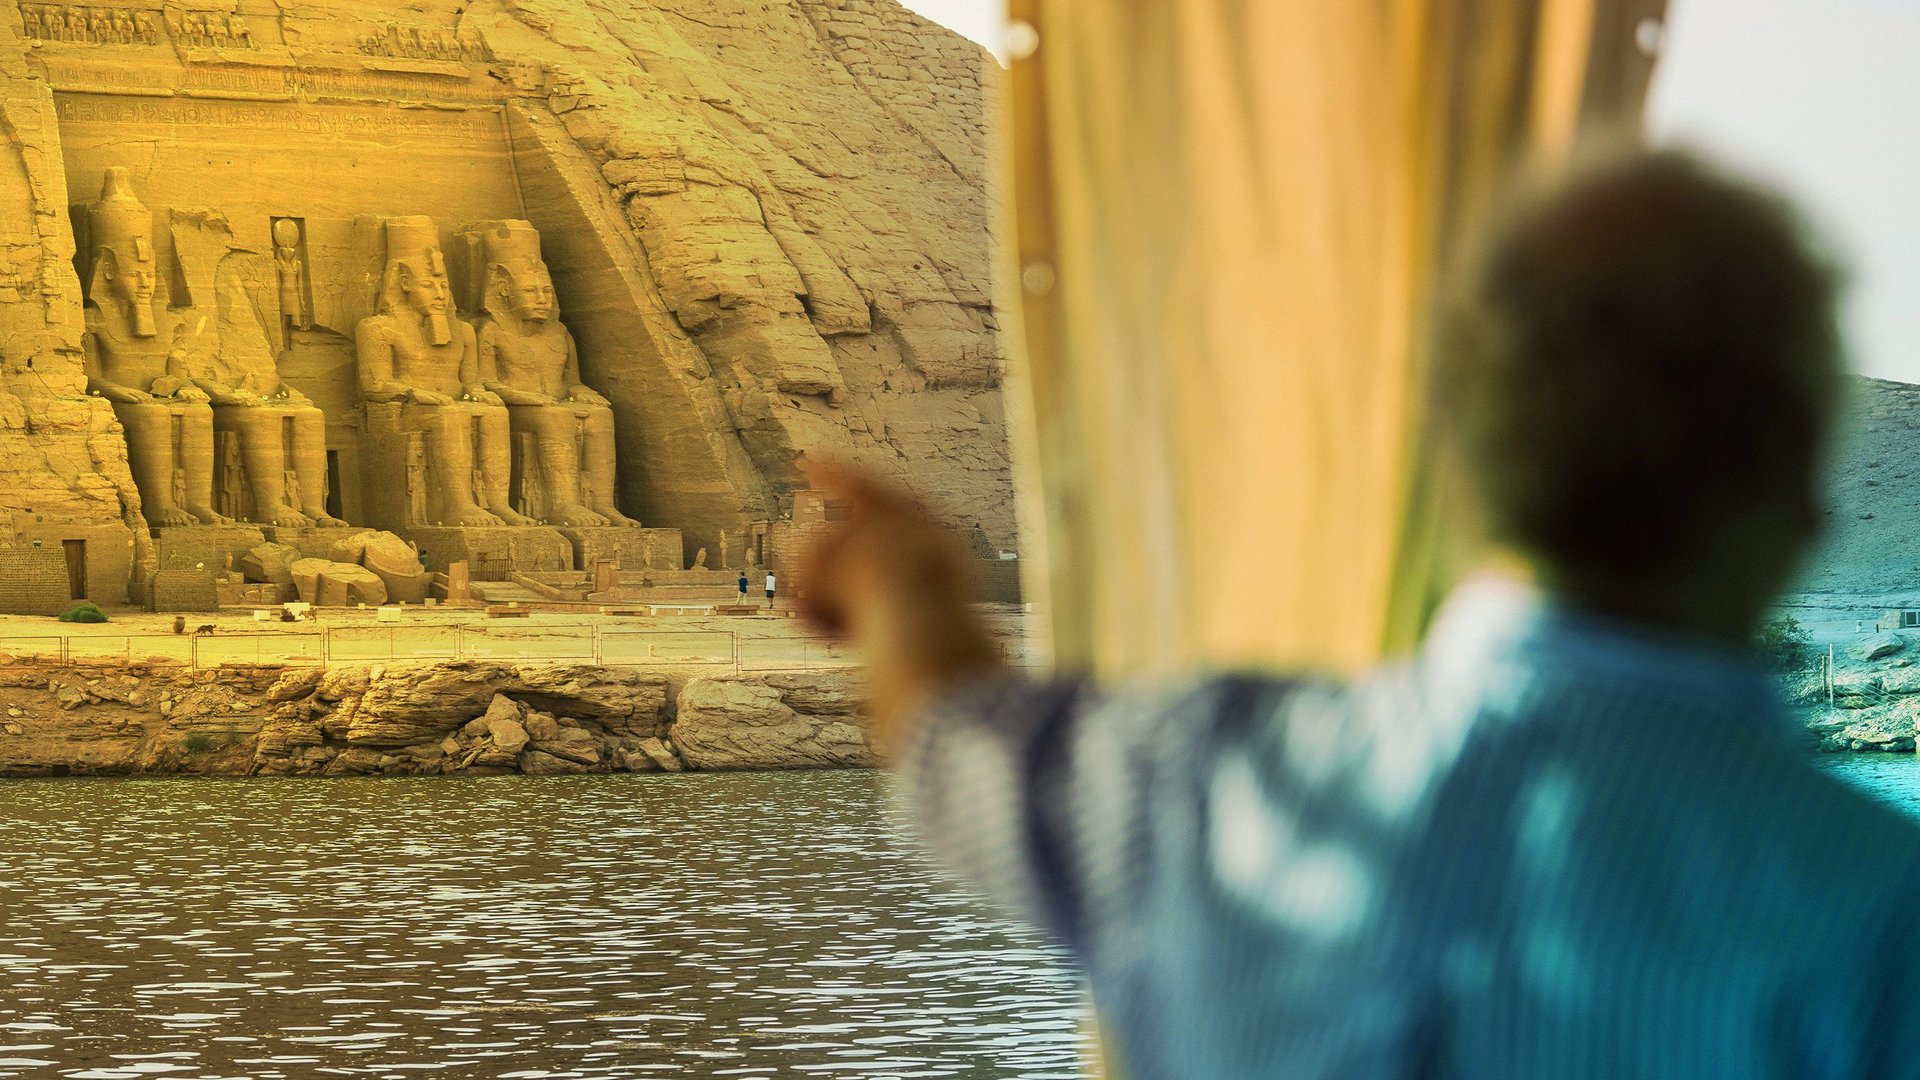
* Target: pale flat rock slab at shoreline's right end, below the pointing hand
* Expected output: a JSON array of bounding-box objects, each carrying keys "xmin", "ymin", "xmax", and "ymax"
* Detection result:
[{"xmin": 674, "ymin": 671, "xmax": 876, "ymax": 769}]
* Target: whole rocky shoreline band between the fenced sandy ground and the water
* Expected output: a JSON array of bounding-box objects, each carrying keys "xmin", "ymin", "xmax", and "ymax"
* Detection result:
[{"xmin": 0, "ymin": 661, "xmax": 874, "ymax": 776}]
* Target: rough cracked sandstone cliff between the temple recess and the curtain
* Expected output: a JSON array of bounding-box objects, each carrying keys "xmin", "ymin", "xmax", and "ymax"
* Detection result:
[{"xmin": 465, "ymin": 0, "xmax": 1012, "ymax": 548}]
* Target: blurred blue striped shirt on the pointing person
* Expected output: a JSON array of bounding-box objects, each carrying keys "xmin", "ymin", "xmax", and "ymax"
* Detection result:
[{"xmin": 900, "ymin": 578, "xmax": 1920, "ymax": 1080}]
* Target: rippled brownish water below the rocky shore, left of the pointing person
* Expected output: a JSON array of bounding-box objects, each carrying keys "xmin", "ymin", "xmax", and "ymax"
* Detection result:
[{"xmin": 0, "ymin": 773, "xmax": 1079, "ymax": 1078}]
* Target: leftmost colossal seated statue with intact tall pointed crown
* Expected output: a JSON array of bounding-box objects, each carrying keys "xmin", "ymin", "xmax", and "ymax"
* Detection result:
[{"xmin": 83, "ymin": 165, "xmax": 228, "ymax": 527}]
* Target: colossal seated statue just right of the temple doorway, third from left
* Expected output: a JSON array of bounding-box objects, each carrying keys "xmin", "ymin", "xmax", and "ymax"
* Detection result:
[{"xmin": 353, "ymin": 217, "xmax": 534, "ymax": 525}]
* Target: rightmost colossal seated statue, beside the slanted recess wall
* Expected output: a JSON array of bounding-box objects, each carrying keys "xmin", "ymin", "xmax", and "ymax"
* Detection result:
[{"xmin": 472, "ymin": 221, "xmax": 639, "ymax": 527}]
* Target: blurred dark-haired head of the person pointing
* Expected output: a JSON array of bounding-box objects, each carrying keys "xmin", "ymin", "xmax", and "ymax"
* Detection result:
[{"xmin": 1434, "ymin": 152, "xmax": 1843, "ymax": 638}]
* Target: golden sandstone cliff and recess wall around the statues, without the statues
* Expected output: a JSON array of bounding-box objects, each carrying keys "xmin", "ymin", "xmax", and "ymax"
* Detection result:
[{"xmin": 0, "ymin": 0, "xmax": 1014, "ymax": 592}]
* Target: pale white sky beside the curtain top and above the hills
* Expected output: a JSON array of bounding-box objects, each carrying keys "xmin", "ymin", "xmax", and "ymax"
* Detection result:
[{"xmin": 904, "ymin": 0, "xmax": 1920, "ymax": 382}]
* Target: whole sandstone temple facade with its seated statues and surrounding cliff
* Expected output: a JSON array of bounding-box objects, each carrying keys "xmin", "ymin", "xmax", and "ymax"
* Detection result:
[{"xmin": 0, "ymin": 0, "xmax": 1014, "ymax": 611}]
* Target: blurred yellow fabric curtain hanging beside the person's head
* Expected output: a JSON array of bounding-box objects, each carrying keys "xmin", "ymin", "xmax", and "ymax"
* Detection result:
[{"xmin": 1008, "ymin": 0, "xmax": 1665, "ymax": 673}]
